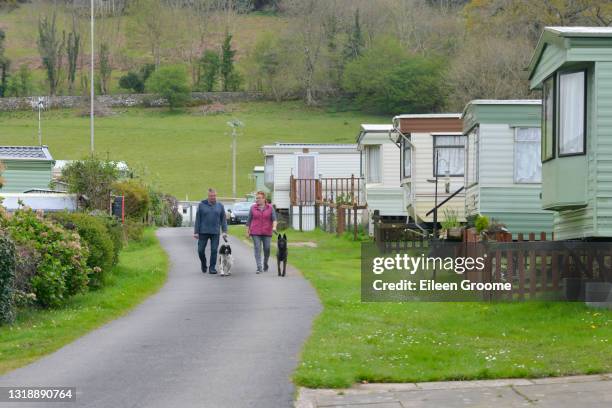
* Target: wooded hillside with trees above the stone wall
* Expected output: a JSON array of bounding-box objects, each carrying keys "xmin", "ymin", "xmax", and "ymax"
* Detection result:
[{"xmin": 0, "ymin": 0, "xmax": 612, "ymax": 113}]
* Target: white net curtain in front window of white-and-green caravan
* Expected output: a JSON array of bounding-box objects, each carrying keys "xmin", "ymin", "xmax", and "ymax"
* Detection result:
[{"xmin": 514, "ymin": 128, "xmax": 542, "ymax": 183}]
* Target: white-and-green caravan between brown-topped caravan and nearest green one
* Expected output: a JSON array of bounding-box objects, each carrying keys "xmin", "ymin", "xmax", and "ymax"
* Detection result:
[{"xmin": 463, "ymin": 100, "xmax": 553, "ymax": 238}]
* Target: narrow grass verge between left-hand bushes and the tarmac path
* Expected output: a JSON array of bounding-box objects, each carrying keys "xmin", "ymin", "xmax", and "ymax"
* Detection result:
[{"xmin": 0, "ymin": 229, "xmax": 168, "ymax": 374}]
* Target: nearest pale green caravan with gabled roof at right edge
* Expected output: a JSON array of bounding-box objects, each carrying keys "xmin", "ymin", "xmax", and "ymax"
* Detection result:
[{"xmin": 529, "ymin": 27, "xmax": 612, "ymax": 239}]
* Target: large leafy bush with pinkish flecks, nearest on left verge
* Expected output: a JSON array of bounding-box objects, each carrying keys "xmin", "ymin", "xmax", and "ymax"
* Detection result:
[{"xmin": 4, "ymin": 208, "xmax": 90, "ymax": 307}]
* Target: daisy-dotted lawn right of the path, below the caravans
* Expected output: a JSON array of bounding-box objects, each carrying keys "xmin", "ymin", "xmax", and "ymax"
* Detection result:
[{"xmin": 228, "ymin": 228, "xmax": 612, "ymax": 387}]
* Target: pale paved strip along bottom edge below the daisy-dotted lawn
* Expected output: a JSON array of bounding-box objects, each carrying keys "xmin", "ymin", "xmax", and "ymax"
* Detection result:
[{"xmin": 296, "ymin": 374, "xmax": 612, "ymax": 408}]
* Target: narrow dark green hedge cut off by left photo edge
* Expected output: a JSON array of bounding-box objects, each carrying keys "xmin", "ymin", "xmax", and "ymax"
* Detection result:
[{"xmin": 0, "ymin": 230, "xmax": 15, "ymax": 324}]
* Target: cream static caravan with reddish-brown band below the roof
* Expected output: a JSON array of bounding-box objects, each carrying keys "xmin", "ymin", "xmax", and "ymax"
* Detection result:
[{"xmin": 393, "ymin": 113, "xmax": 465, "ymax": 224}]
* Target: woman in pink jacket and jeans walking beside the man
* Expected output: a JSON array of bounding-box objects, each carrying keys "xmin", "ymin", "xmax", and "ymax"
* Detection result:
[{"xmin": 246, "ymin": 191, "xmax": 276, "ymax": 273}]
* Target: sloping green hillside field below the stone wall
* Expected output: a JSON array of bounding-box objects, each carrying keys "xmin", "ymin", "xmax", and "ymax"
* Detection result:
[{"xmin": 0, "ymin": 102, "xmax": 384, "ymax": 199}]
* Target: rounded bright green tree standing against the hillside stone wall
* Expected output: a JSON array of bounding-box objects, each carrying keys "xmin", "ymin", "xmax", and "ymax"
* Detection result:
[{"xmin": 145, "ymin": 66, "xmax": 191, "ymax": 108}]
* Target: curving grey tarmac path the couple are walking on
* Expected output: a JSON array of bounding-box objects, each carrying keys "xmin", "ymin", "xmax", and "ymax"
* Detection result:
[{"xmin": 0, "ymin": 228, "xmax": 321, "ymax": 408}]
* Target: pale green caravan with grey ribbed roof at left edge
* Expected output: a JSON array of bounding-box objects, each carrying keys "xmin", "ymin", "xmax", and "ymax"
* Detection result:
[{"xmin": 0, "ymin": 146, "xmax": 55, "ymax": 193}]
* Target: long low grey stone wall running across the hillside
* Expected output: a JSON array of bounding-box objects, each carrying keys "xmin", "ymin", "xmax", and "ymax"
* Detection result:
[{"xmin": 0, "ymin": 92, "xmax": 263, "ymax": 111}]
